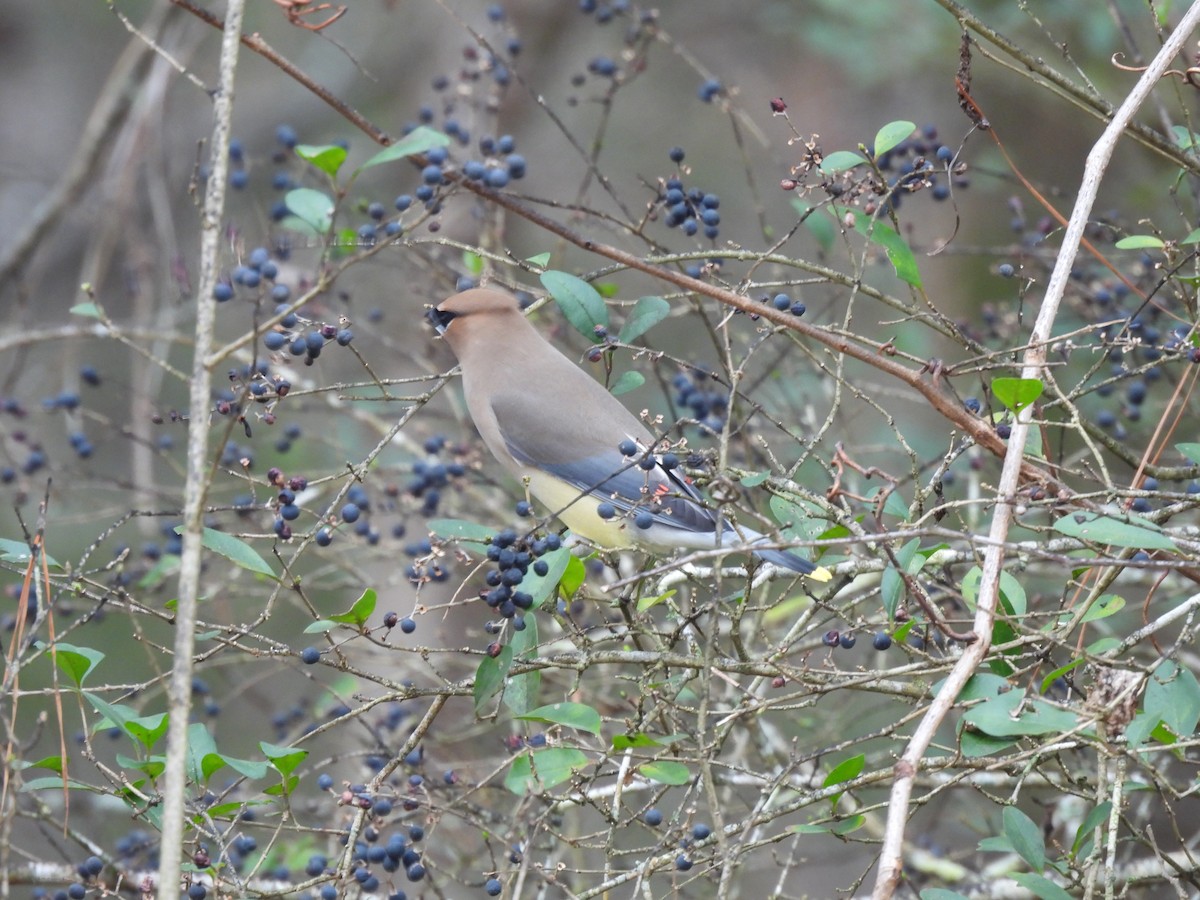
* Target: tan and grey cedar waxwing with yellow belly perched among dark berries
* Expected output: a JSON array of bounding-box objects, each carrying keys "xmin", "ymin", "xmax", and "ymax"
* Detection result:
[{"xmin": 428, "ymin": 289, "xmax": 830, "ymax": 581}]
